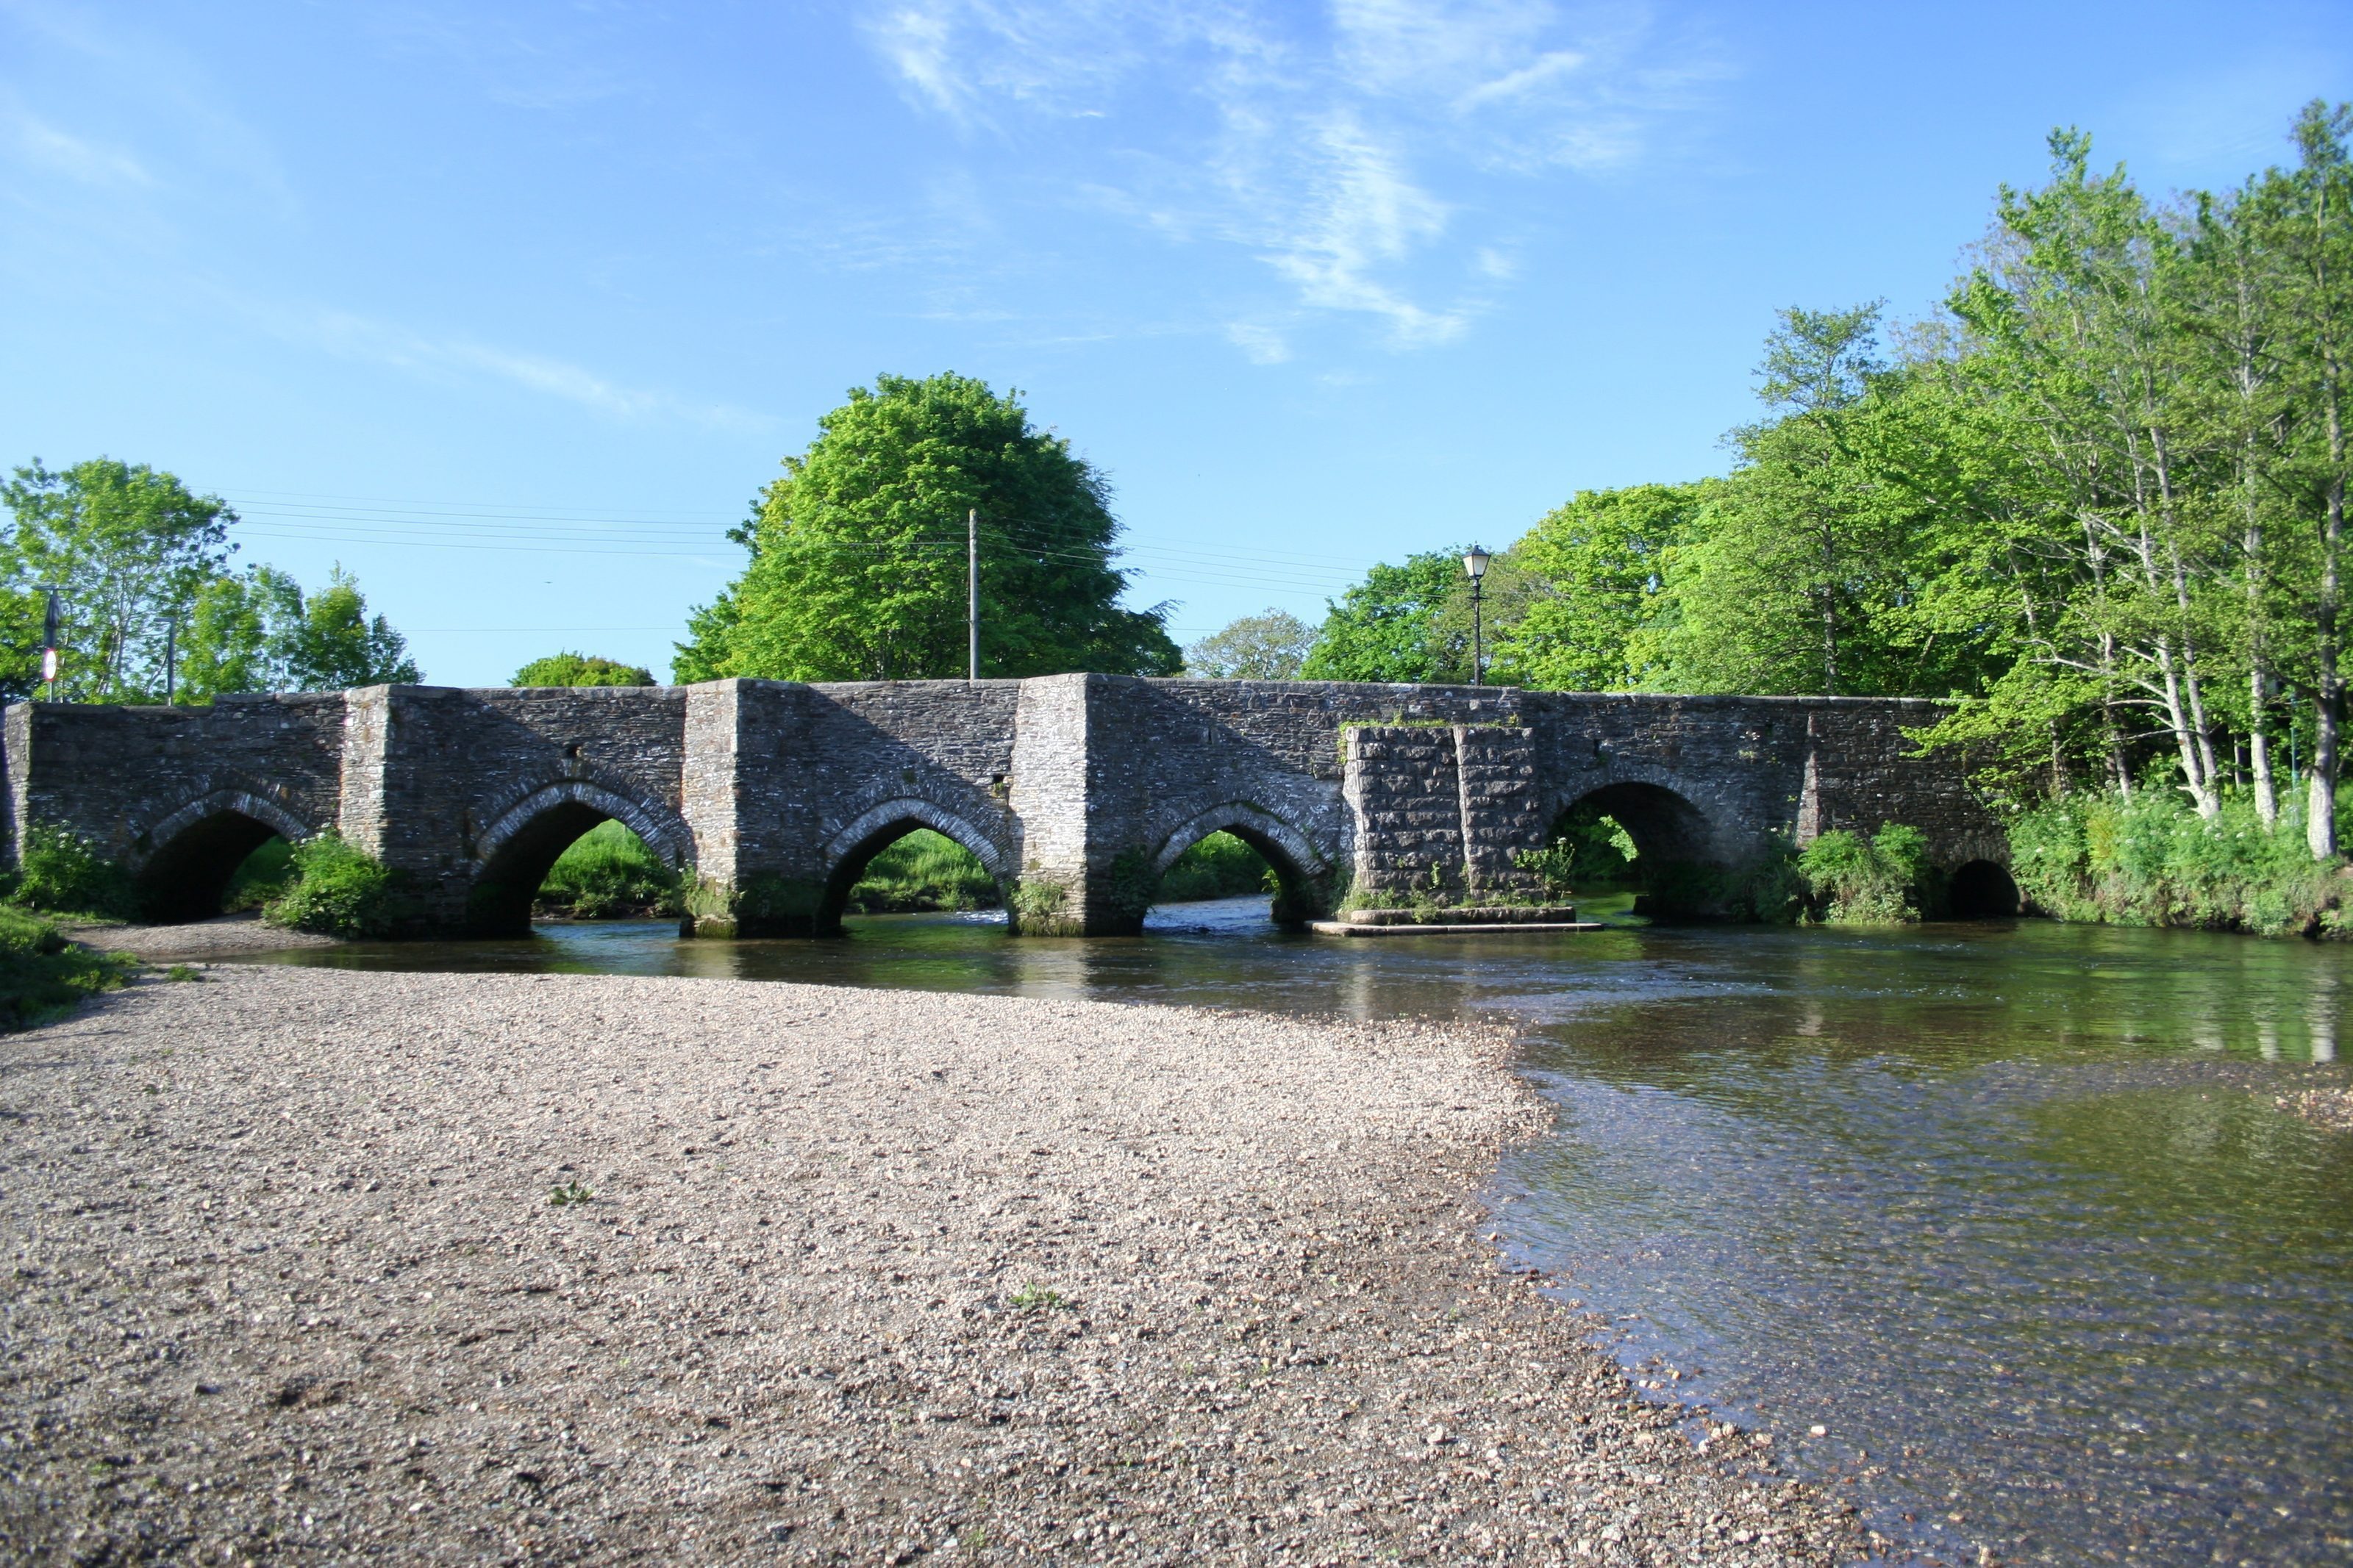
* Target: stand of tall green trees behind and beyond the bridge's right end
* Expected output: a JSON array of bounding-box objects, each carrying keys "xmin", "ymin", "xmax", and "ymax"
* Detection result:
[{"xmin": 1308, "ymin": 104, "xmax": 2353, "ymax": 860}]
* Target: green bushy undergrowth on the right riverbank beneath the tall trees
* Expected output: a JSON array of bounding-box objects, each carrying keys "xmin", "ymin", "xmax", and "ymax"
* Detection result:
[{"xmin": 2010, "ymin": 790, "xmax": 2343, "ymax": 936}]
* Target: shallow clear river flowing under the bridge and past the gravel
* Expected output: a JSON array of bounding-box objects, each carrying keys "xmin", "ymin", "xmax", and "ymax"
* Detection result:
[{"xmin": 234, "ymin": 898, "xmax": 2353, "ymax": 1566}]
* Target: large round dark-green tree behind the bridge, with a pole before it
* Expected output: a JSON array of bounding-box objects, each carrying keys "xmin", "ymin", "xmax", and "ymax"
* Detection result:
[{"xmin": 673, "ymin": 373, "xmax": 1181, "ymax": 681}]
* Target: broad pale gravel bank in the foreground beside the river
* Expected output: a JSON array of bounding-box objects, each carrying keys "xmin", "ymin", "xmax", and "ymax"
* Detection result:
[{"xmin": 0, "ymin": 966, "xmax": 1859, "ymax": 1564}]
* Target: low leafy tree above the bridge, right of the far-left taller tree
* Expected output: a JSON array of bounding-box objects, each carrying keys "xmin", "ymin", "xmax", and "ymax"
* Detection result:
[{"xmin": 179, "ymin": 567, "xmax": 424, "ymax": 703}]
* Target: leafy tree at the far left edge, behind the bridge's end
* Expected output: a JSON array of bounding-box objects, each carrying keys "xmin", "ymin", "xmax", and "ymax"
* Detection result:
[{"xmin": 0, "ymin": 459, "xmax": 238, "ymax": 703}]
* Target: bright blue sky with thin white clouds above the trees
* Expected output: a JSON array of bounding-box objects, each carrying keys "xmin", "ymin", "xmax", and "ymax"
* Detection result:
[{"xmin": 0, "ymin": 0, "xmax": 2353, "ymax": 684}]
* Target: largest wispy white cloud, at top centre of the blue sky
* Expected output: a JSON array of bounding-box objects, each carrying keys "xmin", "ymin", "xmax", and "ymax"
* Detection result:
[{"xmin": 866, "ymin": 0, "xmax": 1720, "ymax": 362}]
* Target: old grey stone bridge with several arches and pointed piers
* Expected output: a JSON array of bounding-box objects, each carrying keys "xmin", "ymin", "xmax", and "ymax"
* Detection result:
[{"xmin": 0, "ymin": 675, "xmax": 2007, "ymax": 936}]
